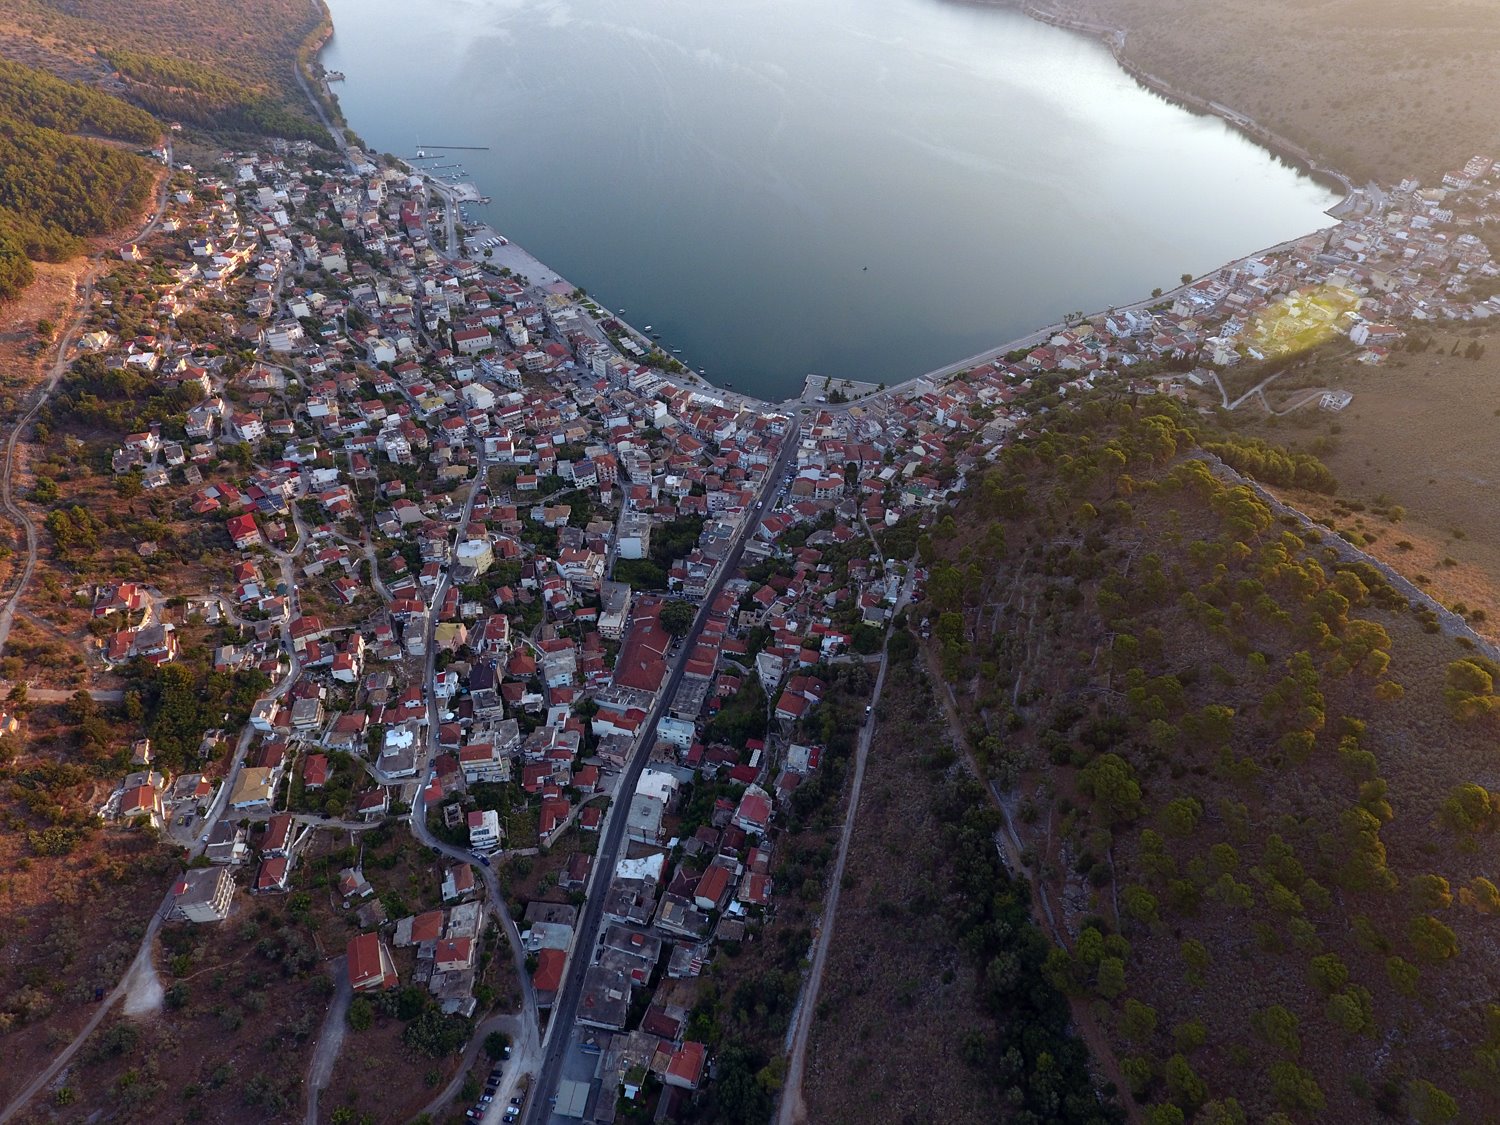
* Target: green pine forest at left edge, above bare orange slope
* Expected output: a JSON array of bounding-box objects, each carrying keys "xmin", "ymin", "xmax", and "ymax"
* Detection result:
[{"xmin": 0, "ymin": 62, "xmax": 161, "ymax": 300}]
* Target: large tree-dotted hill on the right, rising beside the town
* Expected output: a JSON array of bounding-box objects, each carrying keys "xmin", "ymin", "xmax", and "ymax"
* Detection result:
[{"xmin": 920, "ymin": 396, "xmax": 1500, "ymax": 1125}]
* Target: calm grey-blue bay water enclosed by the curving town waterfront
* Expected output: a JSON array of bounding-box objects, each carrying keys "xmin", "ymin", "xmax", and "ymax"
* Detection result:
[{"xmin": 324, "ymin": 0, "xmax": 1337, "ymax": 398}]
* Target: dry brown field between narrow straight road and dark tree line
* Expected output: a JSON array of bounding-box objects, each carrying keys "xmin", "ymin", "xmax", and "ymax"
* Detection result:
[{"xmin": 803, "ymin": 678, "xmax": 995, "ymax": 1122}]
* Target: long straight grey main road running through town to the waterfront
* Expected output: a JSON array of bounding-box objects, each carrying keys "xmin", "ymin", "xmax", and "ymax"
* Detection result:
[{"xmin": 525, "ymin": 417, "xmax": 800, "ymax": 1125}]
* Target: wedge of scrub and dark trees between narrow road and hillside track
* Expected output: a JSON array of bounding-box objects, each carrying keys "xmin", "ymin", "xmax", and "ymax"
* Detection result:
[{"xmin": 804, "ymin": 633, "xmax": 1121, "ymax": 1125}]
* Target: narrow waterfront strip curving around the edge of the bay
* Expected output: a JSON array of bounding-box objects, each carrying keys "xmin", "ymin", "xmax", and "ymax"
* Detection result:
[{"xmin": 310, "ymin": 0, "xmax": 1365, "ymax": 411}]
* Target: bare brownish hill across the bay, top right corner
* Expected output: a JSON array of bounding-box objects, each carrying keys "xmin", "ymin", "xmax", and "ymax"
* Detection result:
[{"xmin": 1023, "ymin": 0, "xmax": 1500, "ymax": 183}]
